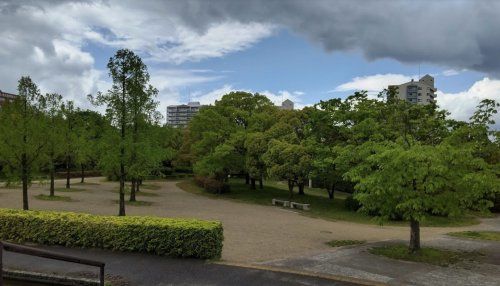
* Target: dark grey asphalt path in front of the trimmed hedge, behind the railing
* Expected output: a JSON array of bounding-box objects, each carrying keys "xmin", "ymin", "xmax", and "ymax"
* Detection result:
[{"xmin": 4, "ymin": 244, "xmax": 356, "ymax": 286}]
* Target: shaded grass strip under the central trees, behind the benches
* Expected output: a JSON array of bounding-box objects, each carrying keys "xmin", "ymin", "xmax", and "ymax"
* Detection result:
[{"xmin": 177, "ymin": 179, "xmax": 479, "ymax": 227}]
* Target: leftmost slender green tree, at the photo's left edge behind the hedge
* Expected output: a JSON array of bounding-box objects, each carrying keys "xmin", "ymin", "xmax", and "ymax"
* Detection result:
[{"xmin": 0, "ymin": 77, "xmax": 46, "ymax": 210}]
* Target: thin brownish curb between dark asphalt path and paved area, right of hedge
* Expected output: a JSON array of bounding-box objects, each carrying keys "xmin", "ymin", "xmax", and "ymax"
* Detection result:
[{"xmin": 213, "ymin": 261, "xmax": 389, "ymax": 286}]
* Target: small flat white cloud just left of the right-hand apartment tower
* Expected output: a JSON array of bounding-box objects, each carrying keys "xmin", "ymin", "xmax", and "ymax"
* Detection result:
[{"xmin": 329, "ymin": 73, "xmax": 411, "ymax": 93}]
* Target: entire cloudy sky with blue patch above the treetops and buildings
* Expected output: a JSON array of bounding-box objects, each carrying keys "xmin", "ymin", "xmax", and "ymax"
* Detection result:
[{"xmin": 0, "ymin": 0, "xmax": 500, "ymax": 125}]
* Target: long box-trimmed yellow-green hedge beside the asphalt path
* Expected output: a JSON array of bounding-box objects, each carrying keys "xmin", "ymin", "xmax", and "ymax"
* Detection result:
[{"xmin": 0, "ymin": 209, "xmax": 223, "ymax": 259}]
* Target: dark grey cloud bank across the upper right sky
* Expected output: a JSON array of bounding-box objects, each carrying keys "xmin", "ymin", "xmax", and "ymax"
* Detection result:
[{"xmin": 157, "ymin": 0, "xmax": 500, "ymax": 75}]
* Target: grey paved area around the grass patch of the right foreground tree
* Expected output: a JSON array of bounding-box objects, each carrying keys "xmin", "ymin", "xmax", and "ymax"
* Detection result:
[{"xmin": 261, "ymin": 236, "xmax": 500, "ymax": 286}]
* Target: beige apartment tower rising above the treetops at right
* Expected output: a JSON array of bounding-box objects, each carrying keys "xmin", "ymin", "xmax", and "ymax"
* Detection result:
[{"xmin": 389, "ymin": 74, "xmax": 437, "ymax": 104}]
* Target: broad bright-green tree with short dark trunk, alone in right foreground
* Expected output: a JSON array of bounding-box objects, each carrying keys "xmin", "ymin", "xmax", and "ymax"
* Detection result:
[{"xmin": 346, "ymin": 139, "xmax": 500, "ymax": 252}]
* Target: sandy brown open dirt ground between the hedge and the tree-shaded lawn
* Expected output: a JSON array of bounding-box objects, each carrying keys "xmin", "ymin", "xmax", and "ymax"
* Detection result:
[{"xmin": 0, "ymin": 178, "xmax": 492, "ymax": 263}]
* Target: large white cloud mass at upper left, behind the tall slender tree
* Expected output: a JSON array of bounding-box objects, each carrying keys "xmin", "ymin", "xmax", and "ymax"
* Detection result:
[{"xmin": 0, "ymin": 0, "xmax": 274, "ymax": 110}]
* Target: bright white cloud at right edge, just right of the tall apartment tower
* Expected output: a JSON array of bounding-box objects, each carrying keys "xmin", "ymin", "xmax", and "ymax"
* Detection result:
[{"xmin": 437, "ymin": 77, "xmax": 500, "ymax": 125}]
